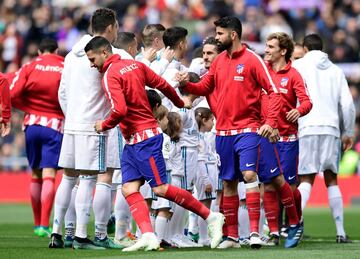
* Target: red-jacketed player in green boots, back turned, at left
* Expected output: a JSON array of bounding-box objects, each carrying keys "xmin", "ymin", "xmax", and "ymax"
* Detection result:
[{"xmin": 10, "ymin": 39, "xmax": 64, "ymax": 239}]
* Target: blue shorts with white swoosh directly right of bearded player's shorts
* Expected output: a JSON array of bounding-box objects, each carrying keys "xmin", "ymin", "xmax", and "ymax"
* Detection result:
[{"xmin": 258, "ymin": 138, "xmax": 282, "ymax": 184}]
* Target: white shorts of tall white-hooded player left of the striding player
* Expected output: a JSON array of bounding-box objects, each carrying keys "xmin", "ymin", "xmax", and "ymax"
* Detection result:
[{"xmin": 59, "ymin": 133, "xmax": 107, "ymax": 172}]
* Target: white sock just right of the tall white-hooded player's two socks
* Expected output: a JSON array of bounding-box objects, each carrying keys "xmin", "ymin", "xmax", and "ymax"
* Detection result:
[{"xmin": 93, "ymin": 182, "xmax": 111, "ymax": 240}]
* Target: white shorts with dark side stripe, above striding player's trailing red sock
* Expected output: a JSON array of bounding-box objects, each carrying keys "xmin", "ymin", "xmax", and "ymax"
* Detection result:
[{"xmin": 181, "ymin": 147, "xmax": 199, "ymax": 191}]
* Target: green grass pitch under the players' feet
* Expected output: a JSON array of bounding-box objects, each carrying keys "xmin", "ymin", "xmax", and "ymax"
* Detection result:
[{"xmin": 0, "ymin": 204, "xmax": 360, "ymax": 259}]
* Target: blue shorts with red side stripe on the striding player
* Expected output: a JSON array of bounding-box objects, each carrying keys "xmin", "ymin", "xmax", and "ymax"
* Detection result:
[{"xmin": 121, "ymin": 134, "xmax": 167, "ymax": 188}]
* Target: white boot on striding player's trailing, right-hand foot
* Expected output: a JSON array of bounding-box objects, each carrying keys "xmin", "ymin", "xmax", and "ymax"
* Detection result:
[{"xmin": 206, "ymin": 212, "xmax": 225, "ymax": 249}]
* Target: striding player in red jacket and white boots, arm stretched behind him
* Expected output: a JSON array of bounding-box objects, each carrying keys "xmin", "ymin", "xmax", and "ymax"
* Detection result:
[{"xmin": 85, "ymin": 37, "xmax": 224, "ymax": 251}]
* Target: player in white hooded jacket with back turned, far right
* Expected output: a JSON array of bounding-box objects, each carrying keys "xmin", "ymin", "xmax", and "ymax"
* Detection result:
[{"xmin": 293, "ymin": 34, "xmax": 355, "ymax": 243}]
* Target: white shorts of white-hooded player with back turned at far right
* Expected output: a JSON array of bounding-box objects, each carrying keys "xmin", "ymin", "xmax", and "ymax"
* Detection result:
[{"xmin": 298, "ymin": 135, "xmax": 341, "ymax": 175}]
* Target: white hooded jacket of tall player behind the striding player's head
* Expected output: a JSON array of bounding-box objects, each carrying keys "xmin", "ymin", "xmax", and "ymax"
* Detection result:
[{"xmin": 59, "ymin": 35, "xmax": 131, "ymax": 135}]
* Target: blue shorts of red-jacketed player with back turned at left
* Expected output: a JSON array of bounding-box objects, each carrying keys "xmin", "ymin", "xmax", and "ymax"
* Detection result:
[{"xmin": 25, "ymin": 125, "xmax": 63, "ymax": 169}]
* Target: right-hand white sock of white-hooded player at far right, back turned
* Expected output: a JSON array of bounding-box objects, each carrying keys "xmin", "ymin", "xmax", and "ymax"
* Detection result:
[{"xmin": 328, "ymin": 185, "xmax": 346, "ymax": 237}]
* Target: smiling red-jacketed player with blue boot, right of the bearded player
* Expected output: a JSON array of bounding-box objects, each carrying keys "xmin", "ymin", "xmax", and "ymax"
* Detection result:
[{"xmin": 259, "ymin": 32, "xmax": 312, "ymax": 248}]
